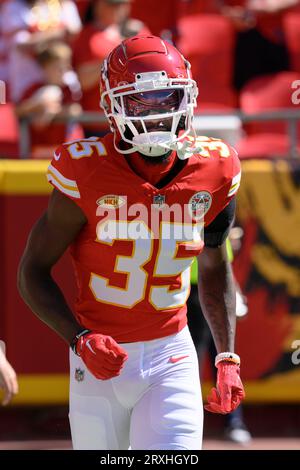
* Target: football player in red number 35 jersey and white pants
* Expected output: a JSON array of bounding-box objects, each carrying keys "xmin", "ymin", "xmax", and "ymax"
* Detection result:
[{"xmin": 19, "ymin": 35, "xmax": 244, "ymax": 450}]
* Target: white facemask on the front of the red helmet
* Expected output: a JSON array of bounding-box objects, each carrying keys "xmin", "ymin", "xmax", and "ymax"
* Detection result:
[{"xmin": 100, "ymin": 67, "xmax": 198, "ymax": 159}]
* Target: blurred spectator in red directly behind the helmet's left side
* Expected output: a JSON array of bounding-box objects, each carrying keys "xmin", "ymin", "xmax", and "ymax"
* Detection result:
[{"xmin": 73, "ymin": 0, "xmax": 149, "ymax": 137}]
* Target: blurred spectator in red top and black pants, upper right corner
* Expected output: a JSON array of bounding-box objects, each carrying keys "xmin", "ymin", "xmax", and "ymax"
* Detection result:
[{"xmin": 220, "ymin": 0, "xmax": 300, "ymax": 90}]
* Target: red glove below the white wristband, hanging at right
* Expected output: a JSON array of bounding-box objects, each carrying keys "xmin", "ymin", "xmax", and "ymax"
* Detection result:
[{"xmin": 204, "ymin": 361, "xmax": 245, "ymax": 414}]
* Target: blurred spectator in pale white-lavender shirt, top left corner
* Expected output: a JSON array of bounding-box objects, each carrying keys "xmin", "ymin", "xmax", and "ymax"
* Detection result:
[{"xmin": 1, "ymin": 0, "xmax": 81, "ymax": 101}]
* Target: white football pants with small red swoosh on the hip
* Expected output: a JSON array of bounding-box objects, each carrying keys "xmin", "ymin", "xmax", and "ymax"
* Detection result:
[{"xmin": 69, "ymin": 327, "xmax": 203, "ymax": 450}]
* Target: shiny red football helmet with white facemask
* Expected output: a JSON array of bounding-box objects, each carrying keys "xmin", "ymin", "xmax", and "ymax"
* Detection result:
[{"xmin": 100, "ymin": 36, "xmax": 198, "ymax": 158}]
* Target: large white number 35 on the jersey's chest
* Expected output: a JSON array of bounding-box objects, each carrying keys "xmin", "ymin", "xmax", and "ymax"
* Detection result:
[{"xmin": 90, "ymin": 221, "xmax": 201, "ymax": 310}]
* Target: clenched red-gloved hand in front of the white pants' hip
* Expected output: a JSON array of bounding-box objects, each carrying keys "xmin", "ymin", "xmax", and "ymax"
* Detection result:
[{"xmin": 76, "ymin": 332, "xmax": 128, "ymax": 380}]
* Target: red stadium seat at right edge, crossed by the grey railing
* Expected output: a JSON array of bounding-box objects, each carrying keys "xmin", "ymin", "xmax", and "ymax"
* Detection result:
[{"xmin": 238, "ymin": 72, "xmax": 300, "ymax": 158}]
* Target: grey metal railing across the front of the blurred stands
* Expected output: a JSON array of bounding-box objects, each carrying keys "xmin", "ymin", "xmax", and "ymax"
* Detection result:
[{"xmin": 19, "ymin": 108, "xmax": 300, "ymax": 158}]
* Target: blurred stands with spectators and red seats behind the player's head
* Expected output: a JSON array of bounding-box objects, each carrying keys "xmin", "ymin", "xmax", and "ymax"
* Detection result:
[{"xmin": 0, "ymin": 0, "xmax": 300, "ymax": 158}]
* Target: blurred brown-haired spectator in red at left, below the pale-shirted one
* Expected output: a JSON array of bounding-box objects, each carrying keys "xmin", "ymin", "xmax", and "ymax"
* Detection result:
[{"xmin": 16, "ymin": 42, "xmax": 82, "ymax": 158}]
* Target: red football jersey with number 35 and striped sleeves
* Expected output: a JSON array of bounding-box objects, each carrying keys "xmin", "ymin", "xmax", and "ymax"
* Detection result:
[{"xmin": 47, "ymin": 134, "xmax": 240, "ymax": 343}]
